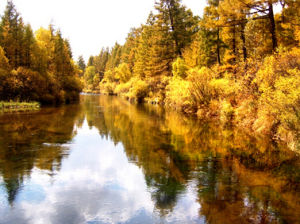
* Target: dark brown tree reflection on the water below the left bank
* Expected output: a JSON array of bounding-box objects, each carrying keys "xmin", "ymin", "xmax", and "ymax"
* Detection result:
[{"xmin": 0, "ymin": 105, "xmax": 84, "ymax": 205}]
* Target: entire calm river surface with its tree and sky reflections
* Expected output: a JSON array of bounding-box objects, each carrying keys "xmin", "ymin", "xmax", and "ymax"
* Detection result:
[{"xmin": 0, "ymin": 95, "xmax": 300, "ymax": 224}]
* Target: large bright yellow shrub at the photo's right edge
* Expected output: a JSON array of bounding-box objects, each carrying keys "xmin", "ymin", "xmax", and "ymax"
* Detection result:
[{"xmin": 254, "ymin": 49, "xmax": 300, "ymax": 144}]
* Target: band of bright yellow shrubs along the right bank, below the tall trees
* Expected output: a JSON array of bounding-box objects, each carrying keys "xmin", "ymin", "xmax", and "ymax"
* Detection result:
[{"xmin": 94, "ymin": 48, "xmax": 300, "ymax": 151}]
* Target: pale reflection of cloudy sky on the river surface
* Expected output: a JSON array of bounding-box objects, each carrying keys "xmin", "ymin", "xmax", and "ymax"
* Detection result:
[{"xmin": 0, "ymin": 121, "xmax": 203, "ymax": 224}]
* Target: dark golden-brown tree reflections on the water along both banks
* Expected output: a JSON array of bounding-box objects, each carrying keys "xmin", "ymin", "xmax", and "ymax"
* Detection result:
[{"xmin": 0, "ymin": 95, "xmax": 300, "ymax": 223}]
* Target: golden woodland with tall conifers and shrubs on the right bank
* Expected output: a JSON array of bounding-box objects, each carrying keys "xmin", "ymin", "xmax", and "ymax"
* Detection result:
[{"xmin": 78, "ymin": 0, "xmax": 300, "ymax": 148}]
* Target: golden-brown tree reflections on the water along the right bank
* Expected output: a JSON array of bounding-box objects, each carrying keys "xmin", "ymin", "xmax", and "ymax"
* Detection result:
[{"xmin": 86, "ymin": 97, "xmax": 300, "ymax": 223}]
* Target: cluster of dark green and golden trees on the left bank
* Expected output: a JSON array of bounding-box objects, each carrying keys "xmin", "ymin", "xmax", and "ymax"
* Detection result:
[{"xmin": 0, "ymin": 1, "xmax": 82, "ymax": 103}]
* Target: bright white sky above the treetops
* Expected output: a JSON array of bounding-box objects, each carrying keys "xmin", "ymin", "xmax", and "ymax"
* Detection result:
[{"xmin": 0, "ymin": 0, "xmax": 206, "ymax": 61}]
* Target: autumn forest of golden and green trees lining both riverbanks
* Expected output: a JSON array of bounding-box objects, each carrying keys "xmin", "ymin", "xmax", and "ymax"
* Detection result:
[{"xmin": 0, "ymin": 0, "xmax": 300, "ymax": 149}]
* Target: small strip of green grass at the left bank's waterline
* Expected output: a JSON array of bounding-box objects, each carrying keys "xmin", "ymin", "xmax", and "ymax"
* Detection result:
[{"xmin": 0, "ymin": 101, "xmax": 40, "ymax": 112}]
